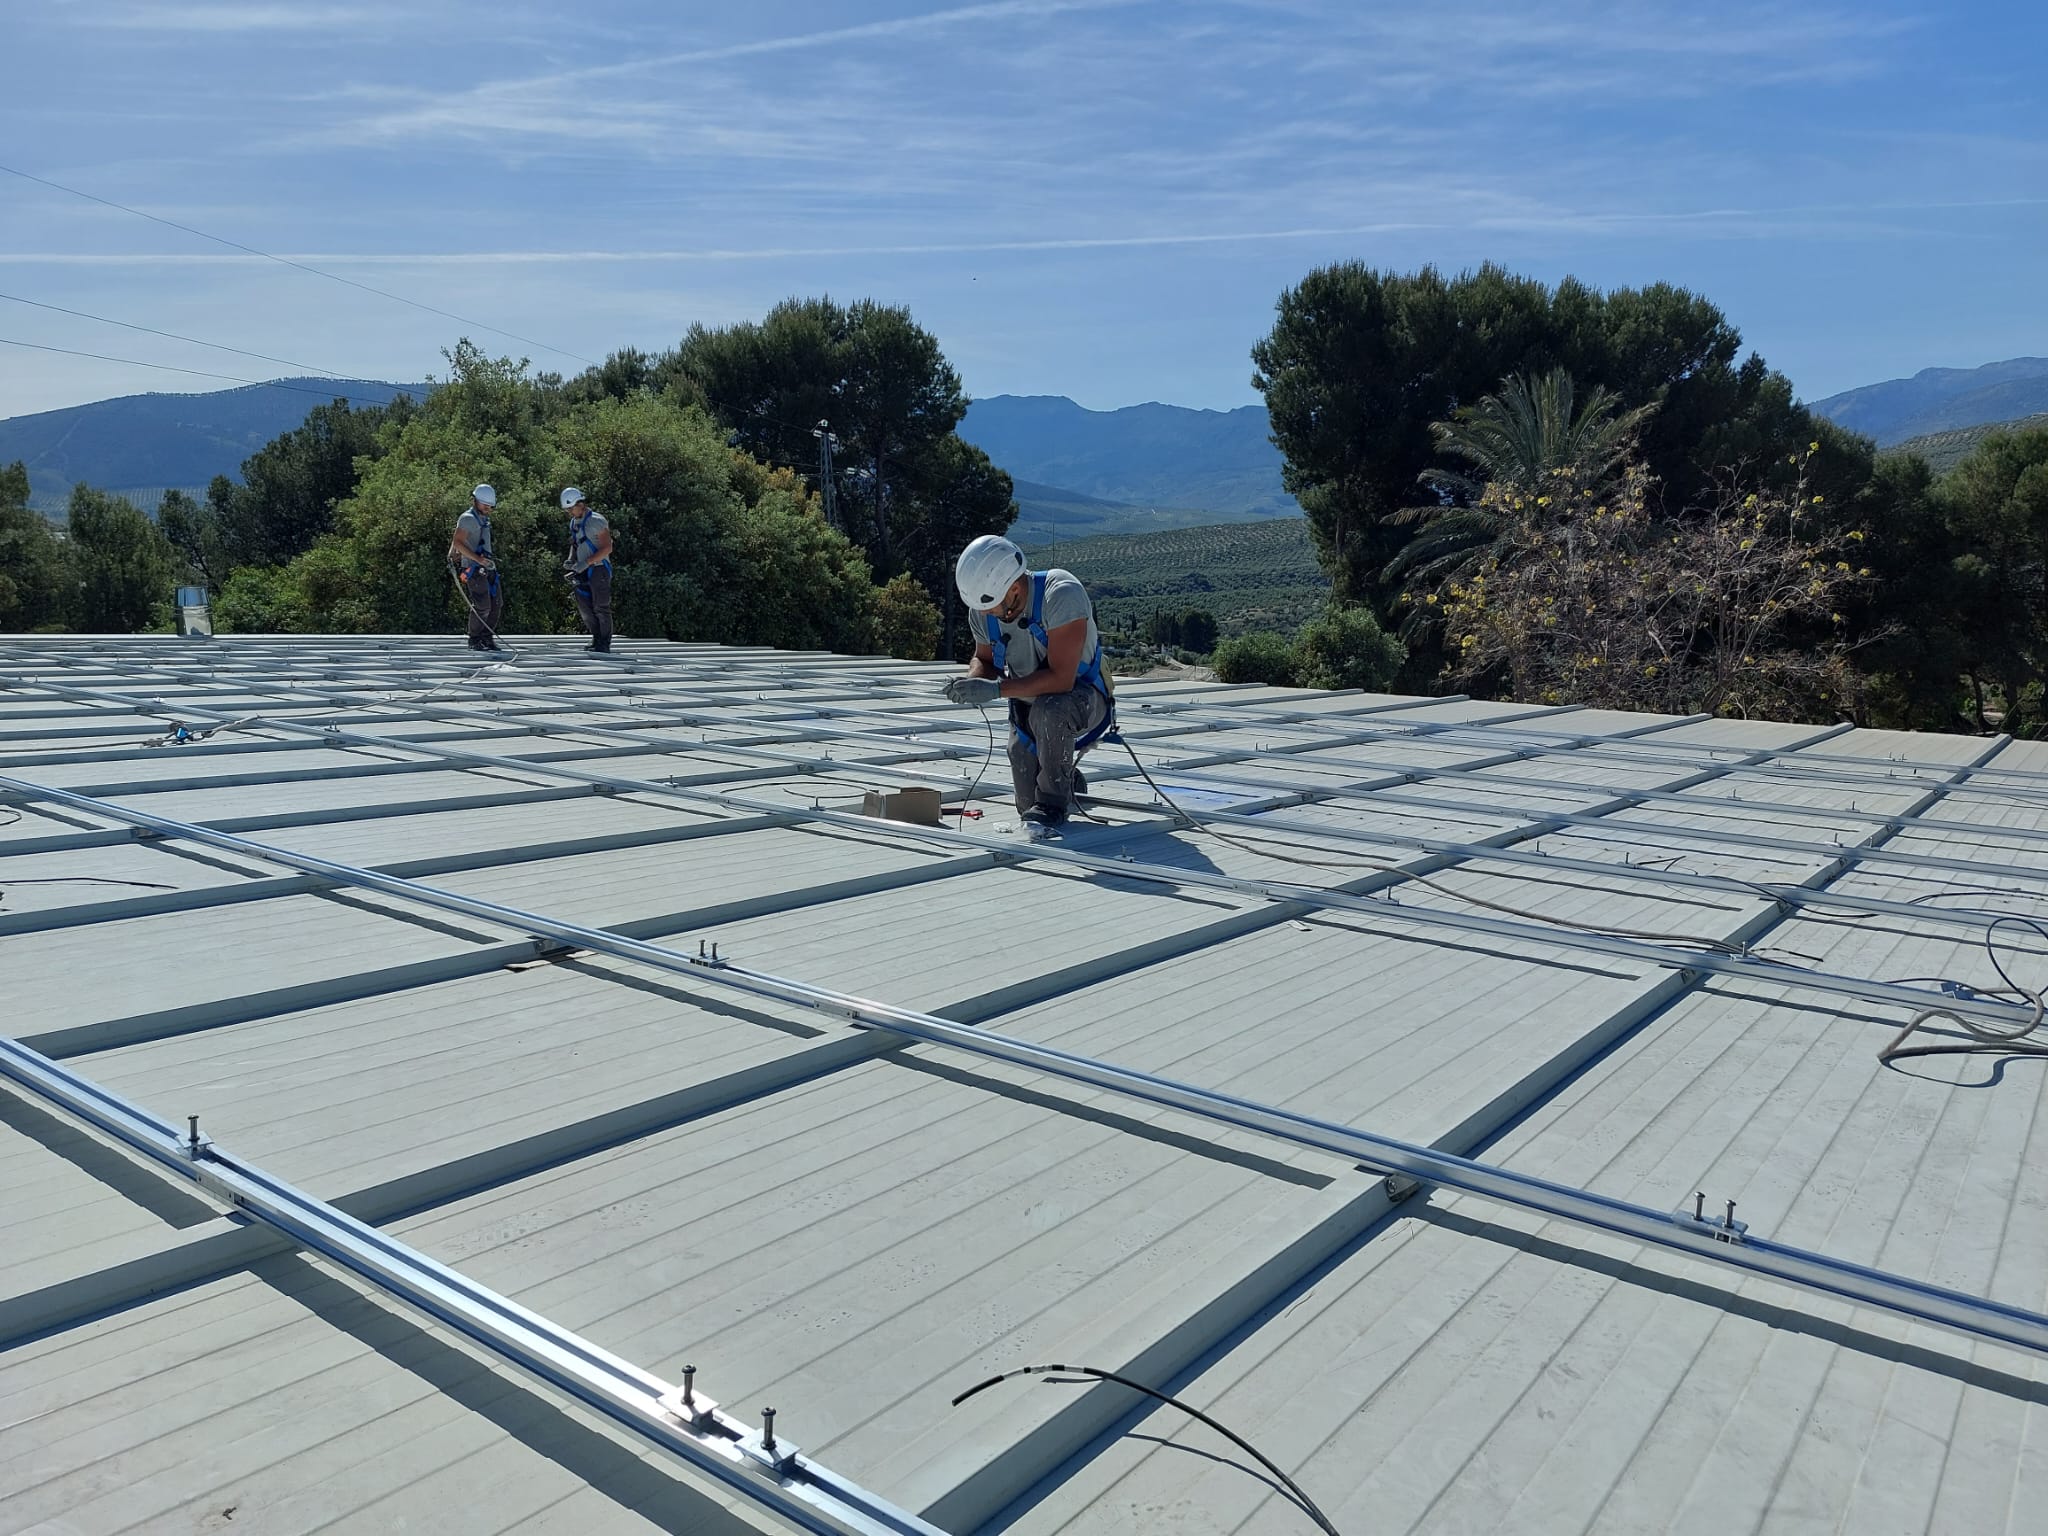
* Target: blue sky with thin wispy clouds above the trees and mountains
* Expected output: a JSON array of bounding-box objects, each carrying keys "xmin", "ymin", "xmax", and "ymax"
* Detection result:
[{"xmin": 0, "ymin": 0, "xmax": 2048, "ymax": 416}]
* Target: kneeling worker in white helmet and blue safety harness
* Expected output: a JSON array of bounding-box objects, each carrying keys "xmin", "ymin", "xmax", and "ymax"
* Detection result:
[{"xmin": 946, "ymin": 532, "xmax": 1116, "ymax": 827}]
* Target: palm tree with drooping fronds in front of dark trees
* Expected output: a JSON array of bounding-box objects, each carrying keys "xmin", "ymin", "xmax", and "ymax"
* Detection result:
[{"xmin": 1386, "ymin": 369, "xmax": 1657, "ymax": 586}]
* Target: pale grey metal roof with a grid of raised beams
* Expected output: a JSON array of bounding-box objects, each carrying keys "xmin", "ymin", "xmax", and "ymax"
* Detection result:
[{"xmin": 0, "ymin": 637, "xmax": 2048, "ymax": 1534}]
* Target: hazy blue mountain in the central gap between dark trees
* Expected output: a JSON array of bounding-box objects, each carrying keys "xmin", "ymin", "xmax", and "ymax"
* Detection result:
[{"xmin": 961, "ymin": 395, "xmax": 1300, "ymax": 516}]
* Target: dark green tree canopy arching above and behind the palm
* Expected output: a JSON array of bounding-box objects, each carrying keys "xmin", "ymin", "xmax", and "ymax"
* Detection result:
[{"xmin": 1251, "ymin": 262, "xmax": 1870, "ymax": 618}]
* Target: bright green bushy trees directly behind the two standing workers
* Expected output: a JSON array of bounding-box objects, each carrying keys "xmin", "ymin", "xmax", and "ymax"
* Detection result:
[{"xmin": 217, "ymin": 346, "xmax": 897, "ymax": 651}]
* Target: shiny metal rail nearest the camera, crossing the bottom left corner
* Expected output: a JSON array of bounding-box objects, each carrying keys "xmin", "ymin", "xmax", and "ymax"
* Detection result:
[{"xmin": 0, "ymin": 1036, "xmax": 944, "ymax": 1536}]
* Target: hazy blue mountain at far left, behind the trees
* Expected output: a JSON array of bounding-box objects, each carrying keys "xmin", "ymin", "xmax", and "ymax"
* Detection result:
[{"xmin": 0, "ymin": 379, "xmax": 426, "ymax": 508}]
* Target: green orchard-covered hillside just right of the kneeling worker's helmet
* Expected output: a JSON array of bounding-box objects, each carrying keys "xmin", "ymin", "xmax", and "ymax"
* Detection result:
[{"xmin": 1030, "ymin": 518, "xmax": 1329, "ymax": 635}]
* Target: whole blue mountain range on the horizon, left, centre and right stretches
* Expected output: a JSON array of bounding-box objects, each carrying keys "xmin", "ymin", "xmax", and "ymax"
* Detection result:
[{"xmin": 0, "ymin": 356, "xmax": 2048, "ymax": 547}]
